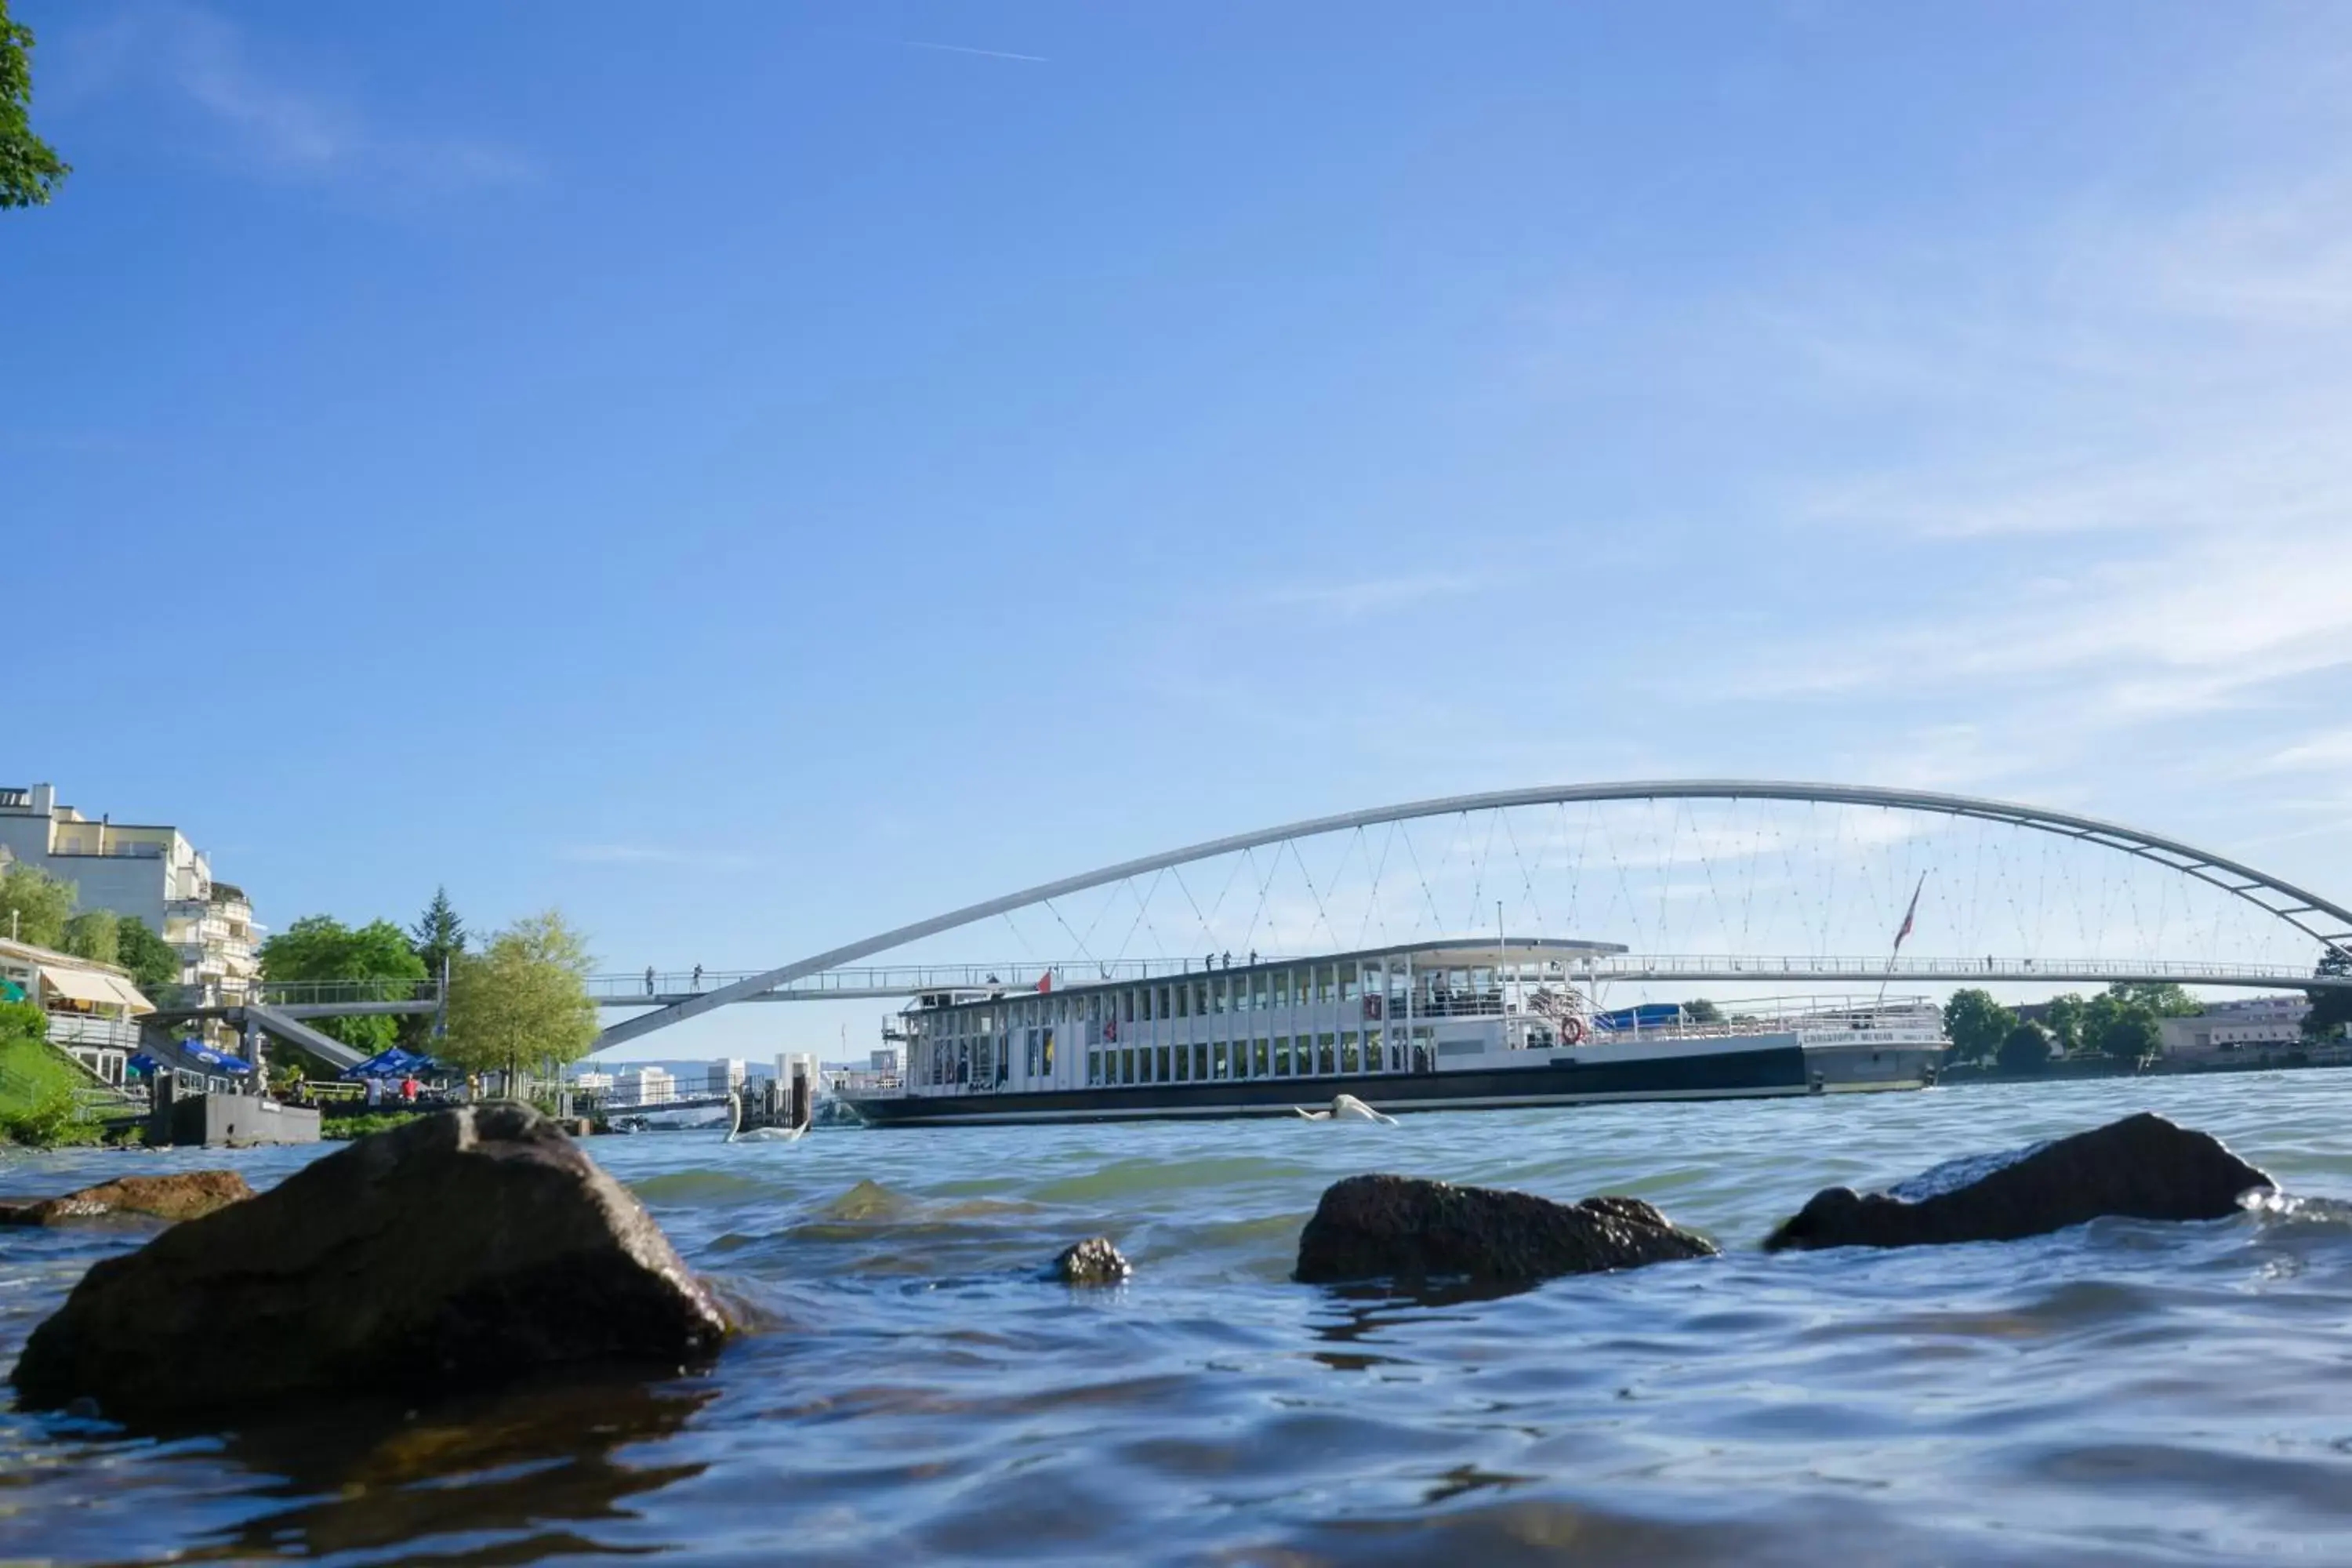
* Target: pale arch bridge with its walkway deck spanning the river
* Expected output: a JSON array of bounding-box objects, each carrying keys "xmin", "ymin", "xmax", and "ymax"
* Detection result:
[{"xmin": 595, "ymin": 779, "xmax": 2352, "ymax": 1051}]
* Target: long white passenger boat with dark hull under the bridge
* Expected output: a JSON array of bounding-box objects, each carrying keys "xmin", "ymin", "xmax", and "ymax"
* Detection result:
[{"xmin": 840, "ymin": 940, "xmax": 1945, "ymax": 1126}]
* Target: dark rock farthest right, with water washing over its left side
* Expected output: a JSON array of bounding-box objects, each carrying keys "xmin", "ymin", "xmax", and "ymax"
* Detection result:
[{"xmin": 1764, "ymin": 1112, "xmax": 2277, "ymax": 1253}]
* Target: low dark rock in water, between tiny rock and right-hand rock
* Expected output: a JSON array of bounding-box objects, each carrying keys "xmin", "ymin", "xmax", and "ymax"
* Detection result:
[{"xmin": 1294, "ymin": 1175, "xmax": 1715, "ymax": 1283}]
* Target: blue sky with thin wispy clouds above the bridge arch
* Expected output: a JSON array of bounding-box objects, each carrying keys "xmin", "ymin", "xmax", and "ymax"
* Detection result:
[{"xmin": 0, "ymin": 0, "xmax": 2352, "ymax": 1051}]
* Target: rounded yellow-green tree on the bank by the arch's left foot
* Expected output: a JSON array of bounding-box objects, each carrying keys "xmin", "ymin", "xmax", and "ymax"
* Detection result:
[{"xmin": 435, "ymin": 909, "xmax": 597, "ymax": 1093}]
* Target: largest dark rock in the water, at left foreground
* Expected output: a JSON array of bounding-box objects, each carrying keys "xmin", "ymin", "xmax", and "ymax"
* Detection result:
[{"xmin": 12, "ymin": 1105, "xmax": 727, "ymax": 1420}]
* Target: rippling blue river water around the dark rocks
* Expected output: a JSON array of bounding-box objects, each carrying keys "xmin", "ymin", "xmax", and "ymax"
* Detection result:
[{"xmin": 0, "ymin": 1072, "xmax": 2352, "ymax": 1566}]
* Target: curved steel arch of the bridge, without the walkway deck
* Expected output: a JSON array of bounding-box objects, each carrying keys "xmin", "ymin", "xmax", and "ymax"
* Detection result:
[{"xmin": 597, "ymin": 779, "xmax": 2352, "ymax": 1048}]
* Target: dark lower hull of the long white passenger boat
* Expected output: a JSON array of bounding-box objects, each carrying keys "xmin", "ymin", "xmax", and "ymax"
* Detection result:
[{"xmin": 844, "ymin": 1036, "xmax": 1816, "ymax": 1126}]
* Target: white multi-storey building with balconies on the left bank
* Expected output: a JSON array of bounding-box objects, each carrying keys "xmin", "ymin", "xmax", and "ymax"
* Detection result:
[{"xmin": 0, "ymin": 783, "xmax": 261, "ymax": 1001}]
